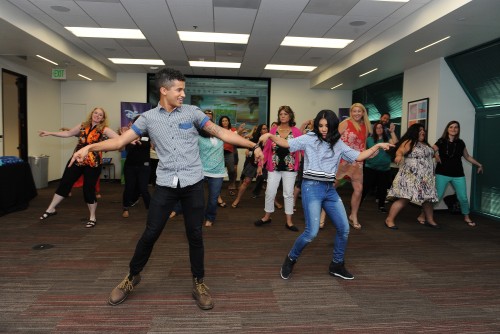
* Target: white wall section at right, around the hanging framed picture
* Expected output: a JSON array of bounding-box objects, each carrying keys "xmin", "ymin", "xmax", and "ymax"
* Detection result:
[{"xmin": 401, "ymin": 58, "xmax": 475, "ymax": 209}]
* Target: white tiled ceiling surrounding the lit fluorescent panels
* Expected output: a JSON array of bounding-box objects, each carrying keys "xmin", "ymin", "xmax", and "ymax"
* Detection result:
[{"xmin": 0, "ymin": 0, "xmax": 500, "ymax": 89}]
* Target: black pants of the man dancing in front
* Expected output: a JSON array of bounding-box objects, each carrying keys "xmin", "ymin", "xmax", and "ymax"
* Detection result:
[{"xmin": 130, "ymin": 181, "xmax": 205, "ymax": 278}]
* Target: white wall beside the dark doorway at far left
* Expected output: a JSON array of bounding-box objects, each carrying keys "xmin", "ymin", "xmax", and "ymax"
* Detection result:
[{"xmin": 0, "ymin": 57, "xmax": 62, "ymax": 180}]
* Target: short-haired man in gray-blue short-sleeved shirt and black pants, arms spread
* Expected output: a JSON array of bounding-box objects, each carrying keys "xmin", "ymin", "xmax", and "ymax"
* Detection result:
[{"xmin": 70, "ymin": 68, "xmax": 263, "ymax": 310}]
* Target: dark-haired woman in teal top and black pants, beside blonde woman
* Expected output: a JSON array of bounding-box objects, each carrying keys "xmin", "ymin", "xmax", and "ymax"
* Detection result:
[{"xmin": 361, "ymin": 122, "xmax": 398, "ymax": 212}]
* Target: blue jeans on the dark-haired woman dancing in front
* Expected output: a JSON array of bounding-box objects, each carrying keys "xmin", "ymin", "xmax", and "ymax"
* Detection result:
[{"xmin": 288, "ymin": 179, "xmax": 349, "ymax": 263}]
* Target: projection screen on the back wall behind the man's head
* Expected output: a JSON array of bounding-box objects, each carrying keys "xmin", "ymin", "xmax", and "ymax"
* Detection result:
[{"xmin": 148, "ymin": 73, "xmax": 271, "ymax": 131}]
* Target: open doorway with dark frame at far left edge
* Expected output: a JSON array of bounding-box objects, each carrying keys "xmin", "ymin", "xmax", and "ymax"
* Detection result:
[{"xmin": 2, "ymin": 69, "xmax": 28, "ymax": 161}]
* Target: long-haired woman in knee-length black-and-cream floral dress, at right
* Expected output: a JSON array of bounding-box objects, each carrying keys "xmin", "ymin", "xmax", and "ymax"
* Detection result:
[{"xmin": 385, "ymin": 124, "xmax": 440, "ymax": 230}]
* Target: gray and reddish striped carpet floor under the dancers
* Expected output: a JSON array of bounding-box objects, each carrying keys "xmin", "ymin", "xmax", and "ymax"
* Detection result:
[{"xmin": 0, "ymin": 183, "xmax": 500, "ymax": 333}]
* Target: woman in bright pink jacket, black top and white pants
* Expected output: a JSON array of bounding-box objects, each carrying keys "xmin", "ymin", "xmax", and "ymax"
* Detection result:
[{"xmin": 255, "ymin": 106, "xmax": 302, "ymax": 232}]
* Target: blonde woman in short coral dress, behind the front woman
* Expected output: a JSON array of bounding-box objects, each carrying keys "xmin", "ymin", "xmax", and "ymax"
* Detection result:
[{"xmin": 335, "ymin": 103, "xmax": 370, "ymax": 230}]
